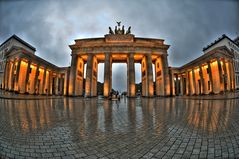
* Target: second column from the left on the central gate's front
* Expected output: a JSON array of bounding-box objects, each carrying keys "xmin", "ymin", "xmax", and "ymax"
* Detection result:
[{"xmin": 85, "ymin": 54, "xmax": 93, "ymax": 97}]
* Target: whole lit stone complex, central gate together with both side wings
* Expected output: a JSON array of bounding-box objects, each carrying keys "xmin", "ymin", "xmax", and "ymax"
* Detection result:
[{"xmin": 0, "ymin": 23, "xmax": 239, "ymax": 97}]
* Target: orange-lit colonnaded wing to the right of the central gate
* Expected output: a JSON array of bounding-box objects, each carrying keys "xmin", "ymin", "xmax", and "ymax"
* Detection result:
[{"xmin": 172, "ymin": 57, "xmax": 235, "ymax": 95}]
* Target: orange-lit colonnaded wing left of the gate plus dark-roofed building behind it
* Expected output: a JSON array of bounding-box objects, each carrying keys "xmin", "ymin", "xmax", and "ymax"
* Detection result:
[{"xmin": 0, "ymin": 35, "xmax": 67, "ymax": 95}]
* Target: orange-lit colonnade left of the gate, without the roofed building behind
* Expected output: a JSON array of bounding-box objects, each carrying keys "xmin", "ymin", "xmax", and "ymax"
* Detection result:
[{"xmin": 2, "ymin": 56, "xmax": 64, "ymax": 95}]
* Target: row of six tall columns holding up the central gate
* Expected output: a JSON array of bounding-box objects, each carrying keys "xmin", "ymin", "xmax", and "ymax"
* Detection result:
[{"xmin": 68, "ymin": 52, "xmax": 170, "ymax": 97}]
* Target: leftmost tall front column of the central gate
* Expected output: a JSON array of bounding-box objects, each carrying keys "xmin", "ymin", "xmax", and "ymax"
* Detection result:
[{"xmin": 69, "ymin": 52, "xmax": 78, "ymax": 96}]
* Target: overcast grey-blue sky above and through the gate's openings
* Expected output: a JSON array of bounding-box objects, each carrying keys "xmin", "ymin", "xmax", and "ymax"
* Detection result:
[{"xmin": 0, "ymin": 0, "xmax": 239, "ymax": 91}]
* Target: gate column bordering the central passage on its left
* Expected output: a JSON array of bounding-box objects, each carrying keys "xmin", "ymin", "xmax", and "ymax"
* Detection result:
[{"xmin": 104, "ymin": 53, "xmax": 112, "ymax": 97}]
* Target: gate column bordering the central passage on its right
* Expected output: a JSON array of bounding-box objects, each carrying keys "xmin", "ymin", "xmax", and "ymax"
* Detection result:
[{"xmin": 127, "ymin": 53, "xmax": 135, "ymax": 97}]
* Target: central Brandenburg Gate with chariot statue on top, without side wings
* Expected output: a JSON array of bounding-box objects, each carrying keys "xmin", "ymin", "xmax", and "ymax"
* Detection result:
[{"xmin": 68, "ymin": 22, "xmax": 170, "ymax": 97}]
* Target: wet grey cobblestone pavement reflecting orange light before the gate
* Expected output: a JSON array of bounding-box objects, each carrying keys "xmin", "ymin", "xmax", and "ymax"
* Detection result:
[{"xmin": 0, "ymin": 98, "xmax": 239, "ymax": 159}]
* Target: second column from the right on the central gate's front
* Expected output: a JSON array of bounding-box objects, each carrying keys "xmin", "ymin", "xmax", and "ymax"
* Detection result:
[{"xmin": 146, "ymin": 54, "xmax": 154, "ymax": 97}]
